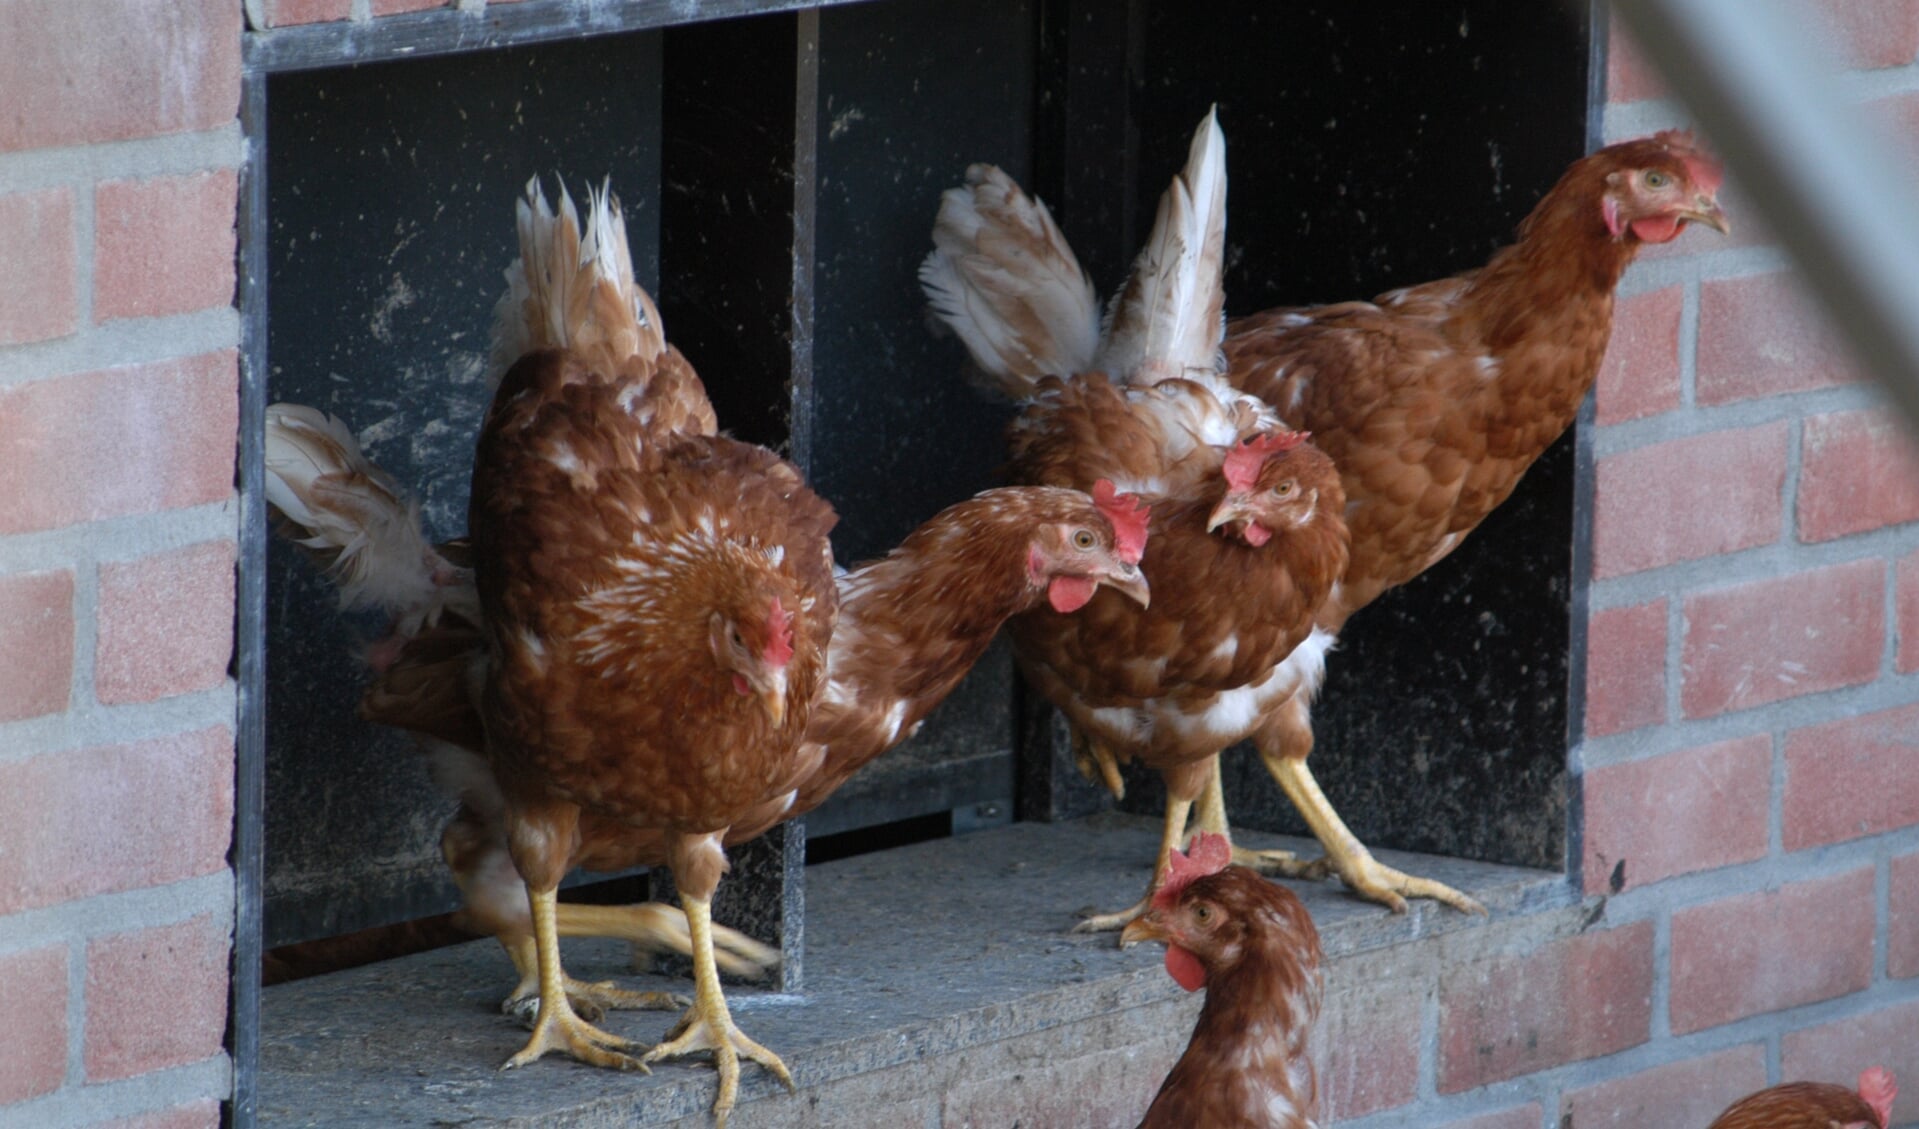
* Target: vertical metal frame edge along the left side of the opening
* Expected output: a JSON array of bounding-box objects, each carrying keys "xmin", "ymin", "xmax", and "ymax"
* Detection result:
[{"xmin": 226, "ymin": 71, "xmax": 267, "ymax": 1129}]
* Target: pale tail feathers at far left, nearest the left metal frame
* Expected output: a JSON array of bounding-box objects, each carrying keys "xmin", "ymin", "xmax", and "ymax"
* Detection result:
[{"xmin": 267, "ymin": 403, "xmax": 478, "ymax": 634}]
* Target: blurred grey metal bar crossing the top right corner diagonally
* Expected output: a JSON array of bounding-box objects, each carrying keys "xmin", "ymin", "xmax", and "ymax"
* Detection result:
[{"xmin": 1616, "ymin": 0, "xmax": 1919, "ymax": 426}]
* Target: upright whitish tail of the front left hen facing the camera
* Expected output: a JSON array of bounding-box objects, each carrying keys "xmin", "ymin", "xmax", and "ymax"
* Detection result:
[{"xmin": 487, "ymin": 177, "xmax": 666, "ymax": 388}]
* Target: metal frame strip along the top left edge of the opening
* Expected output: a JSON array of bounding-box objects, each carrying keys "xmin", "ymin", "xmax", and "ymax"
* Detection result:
[{"xmin": 244, "ymin": 0, "xmax": 865, "ymax": 71}]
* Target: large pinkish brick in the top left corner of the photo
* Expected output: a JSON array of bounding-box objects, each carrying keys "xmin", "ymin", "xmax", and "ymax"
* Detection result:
[{"xmin": 0, "ymin": 0, "xmax": 240, "ymax": 152}]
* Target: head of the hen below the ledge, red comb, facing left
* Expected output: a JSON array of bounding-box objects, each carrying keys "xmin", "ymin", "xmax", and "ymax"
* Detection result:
[{"xmin": 1119, "ymin": 833, "xmax": 1320, "ymax": 991}]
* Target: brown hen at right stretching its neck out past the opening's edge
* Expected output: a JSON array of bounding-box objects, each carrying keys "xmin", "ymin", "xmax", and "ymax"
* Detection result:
[{"xmin": 1211, "ymin": 132, "xmax": 1727, "ymax": 910}]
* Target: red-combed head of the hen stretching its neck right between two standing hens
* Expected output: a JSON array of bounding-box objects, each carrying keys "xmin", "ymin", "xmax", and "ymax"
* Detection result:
[{"xmin": 1027, "ymin": 478, "xmax": 1151, "ymax": 613}]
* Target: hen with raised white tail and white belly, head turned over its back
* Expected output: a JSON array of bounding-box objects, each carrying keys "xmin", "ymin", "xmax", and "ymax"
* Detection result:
[{"xmin": 919, "ymin": 113, "xmax": 1347, "ymax": 931}]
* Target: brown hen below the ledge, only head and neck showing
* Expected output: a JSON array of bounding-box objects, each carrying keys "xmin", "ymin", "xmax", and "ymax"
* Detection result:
[{"xmin": 1121, "ymin": 831, "xmax": 1322, "ymax": 1129}]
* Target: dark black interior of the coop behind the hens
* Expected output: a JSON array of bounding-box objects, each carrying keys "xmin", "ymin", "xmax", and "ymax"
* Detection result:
[{"xmin": 255, "ymin": 0, "xmax": 1589, "ymax": 1108}]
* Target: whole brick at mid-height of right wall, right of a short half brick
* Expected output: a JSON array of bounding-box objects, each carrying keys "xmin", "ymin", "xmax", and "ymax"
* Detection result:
[{"xmin": 1679, "ymin": 561, "xmax": 1886, "ymax": 718}]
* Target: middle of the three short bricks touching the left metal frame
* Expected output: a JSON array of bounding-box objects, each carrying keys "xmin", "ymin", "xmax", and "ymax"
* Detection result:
[{"xmin": 94, "ymin": 541, "xmax": 234, "ymax": 705}]
